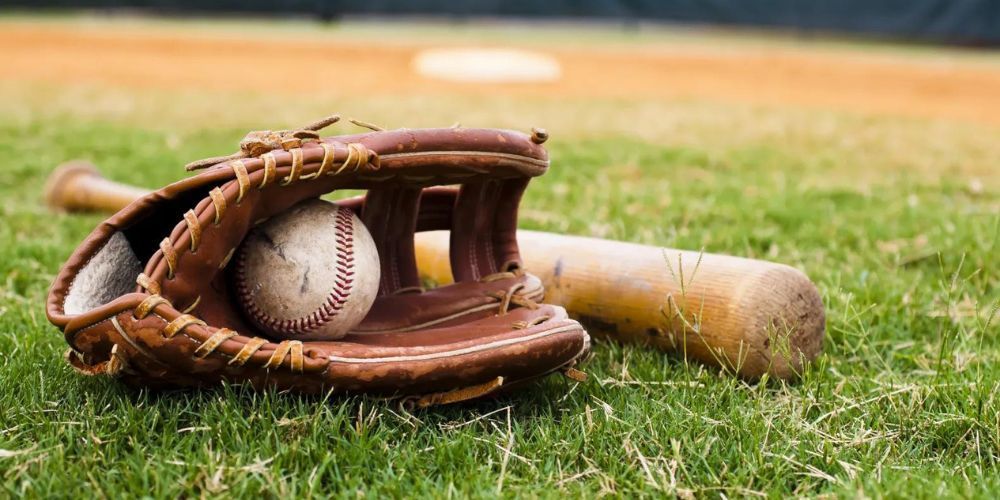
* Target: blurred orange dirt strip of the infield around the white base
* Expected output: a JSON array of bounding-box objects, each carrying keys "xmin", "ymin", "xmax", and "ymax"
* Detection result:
[{"xmin": 0, "ymin": 21, "xmax": 1000, "ymax": 125}]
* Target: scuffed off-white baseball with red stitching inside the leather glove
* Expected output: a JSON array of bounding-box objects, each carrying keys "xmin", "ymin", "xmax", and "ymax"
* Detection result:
[{"xmin": 234, "ymin": 199, "xmax": 380, "ymax": 340}]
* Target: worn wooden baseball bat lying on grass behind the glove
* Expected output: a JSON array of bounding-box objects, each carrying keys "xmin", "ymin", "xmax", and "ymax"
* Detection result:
[{"xmin": 45, "ymin": 162, "xmax": 826, "ymax": 379}]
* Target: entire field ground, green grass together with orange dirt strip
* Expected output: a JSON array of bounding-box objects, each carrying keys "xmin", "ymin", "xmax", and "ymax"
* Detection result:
[{"xmin": 0, "ymin": 16, "xmax": 1000, "ymax": 497}]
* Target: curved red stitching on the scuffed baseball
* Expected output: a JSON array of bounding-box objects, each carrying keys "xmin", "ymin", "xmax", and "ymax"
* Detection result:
[{"xmin": 236, "ymin": 207, "xmax": 354, "ymax": 335}]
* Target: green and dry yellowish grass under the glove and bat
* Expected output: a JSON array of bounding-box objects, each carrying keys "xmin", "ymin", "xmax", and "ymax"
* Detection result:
[{"xmin": 0, "ymin": 15, "xmax": 1000, "ymax": 498}]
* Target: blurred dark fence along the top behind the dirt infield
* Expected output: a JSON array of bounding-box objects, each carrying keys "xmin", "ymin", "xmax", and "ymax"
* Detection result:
[{"xmin": 7, "ymin": 0, "xmax": 1000, "ymax": 45}]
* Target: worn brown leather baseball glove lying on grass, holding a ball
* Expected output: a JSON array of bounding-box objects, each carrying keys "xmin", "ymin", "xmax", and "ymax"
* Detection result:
[{"xmin": 46, "ymin": 118, "xmax": 590, "ymax": 407}]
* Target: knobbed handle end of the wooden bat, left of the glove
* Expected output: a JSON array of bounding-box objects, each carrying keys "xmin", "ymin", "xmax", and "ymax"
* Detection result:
[{"xmin": 45, "ymin": 160, "xmax": 149, "ymax": 212}]
